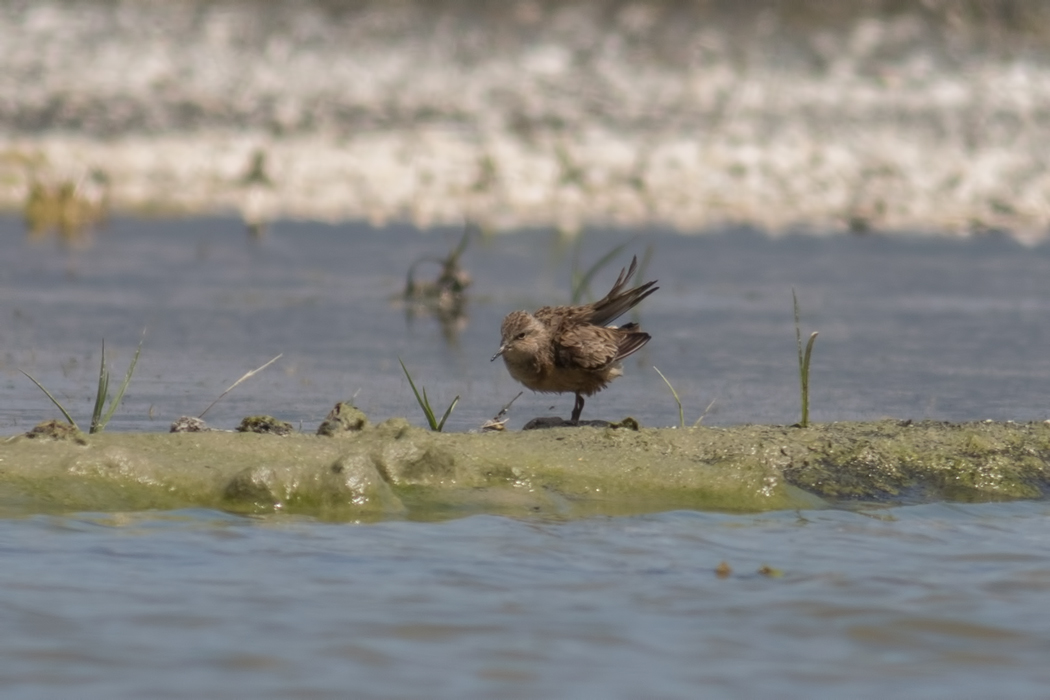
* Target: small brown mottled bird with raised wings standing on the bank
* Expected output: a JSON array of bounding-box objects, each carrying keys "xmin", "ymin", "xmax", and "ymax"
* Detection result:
[{"xmin": 491, "ymin": 256, "xmax": 659, "ymax": 425}]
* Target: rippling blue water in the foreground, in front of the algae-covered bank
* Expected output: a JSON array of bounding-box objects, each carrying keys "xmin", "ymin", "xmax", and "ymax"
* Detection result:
[{"xmin": 6, "ymin": 503, "xmax": 1050, "ymax": 698}]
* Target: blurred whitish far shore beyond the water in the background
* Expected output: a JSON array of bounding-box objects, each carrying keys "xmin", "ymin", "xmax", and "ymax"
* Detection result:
[{"xmin": 6, "ymin": 0, "xmax": 1050, "ymax": 240}]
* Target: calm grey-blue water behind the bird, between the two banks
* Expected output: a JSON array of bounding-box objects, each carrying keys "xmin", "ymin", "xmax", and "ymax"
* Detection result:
[{"xmin": 0, "ymin": 218, "xmax": 1050, "ymax": 432}]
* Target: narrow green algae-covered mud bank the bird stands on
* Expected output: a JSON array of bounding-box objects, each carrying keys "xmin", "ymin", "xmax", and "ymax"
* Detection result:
[{"xmin": 0, "ymin": 419, "xmax": 1050, "ymax": 519}]
